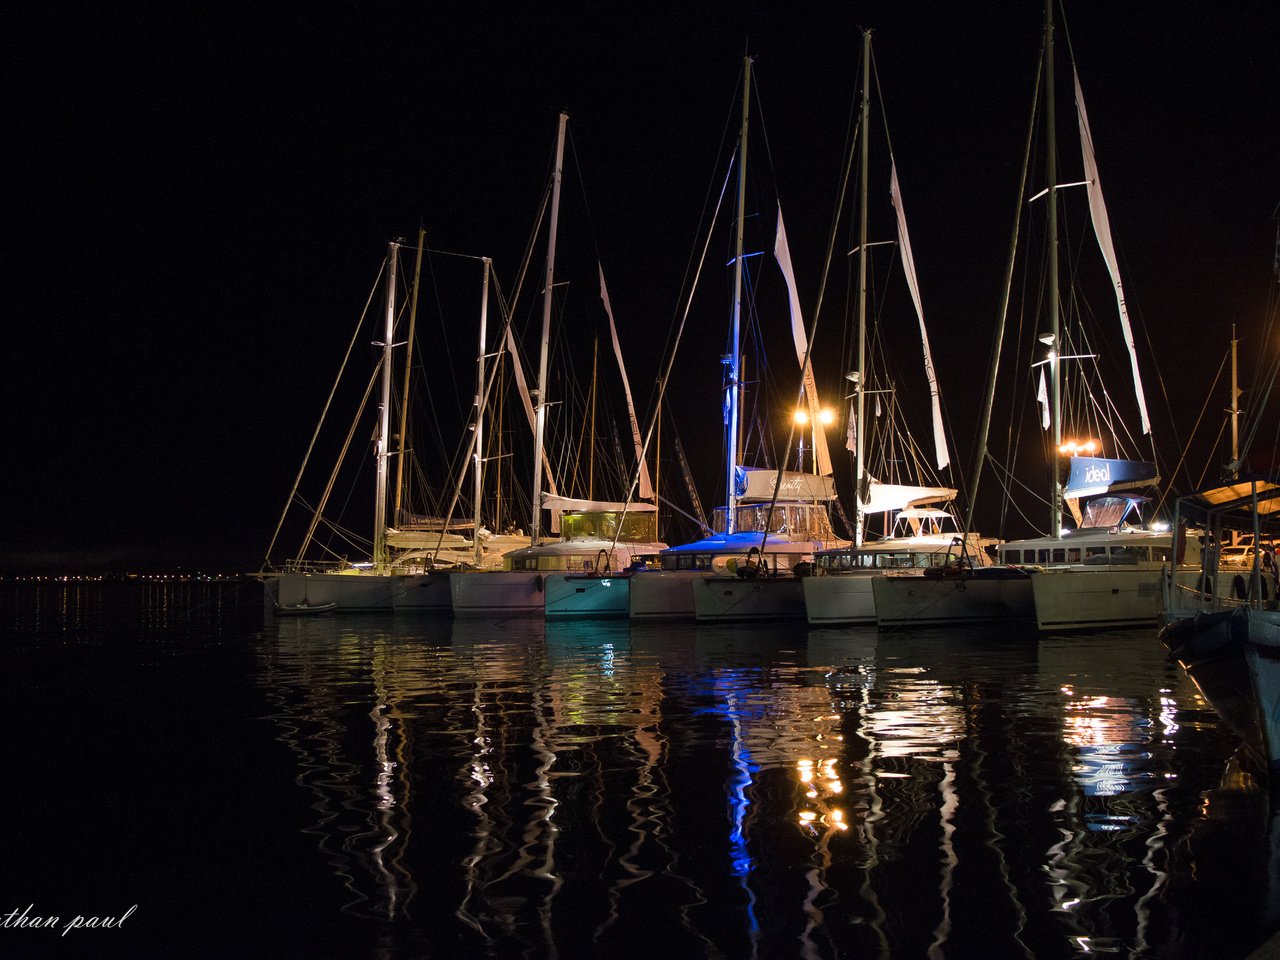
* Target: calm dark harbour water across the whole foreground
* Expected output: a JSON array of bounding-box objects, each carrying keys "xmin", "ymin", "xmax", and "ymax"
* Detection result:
[{"xmin": 0, "ymin": 584, "xmax": 1280, "ymax": 960}]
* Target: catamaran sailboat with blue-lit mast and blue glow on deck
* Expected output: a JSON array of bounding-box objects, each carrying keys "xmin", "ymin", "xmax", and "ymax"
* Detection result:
[{"xmin": 627, "ymin": 58, "xmax": 841, "ymax": 620}]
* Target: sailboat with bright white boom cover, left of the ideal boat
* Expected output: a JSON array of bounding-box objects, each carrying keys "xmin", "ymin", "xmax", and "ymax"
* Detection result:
[{"xmin": 803, "ymin": 31, "xmax": 995, "ymax": 625}]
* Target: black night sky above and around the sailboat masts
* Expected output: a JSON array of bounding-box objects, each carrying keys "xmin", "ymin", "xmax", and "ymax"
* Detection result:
[{"xmin": 0, "ymin": 0, "xmax": 1280, "ymax": 573}]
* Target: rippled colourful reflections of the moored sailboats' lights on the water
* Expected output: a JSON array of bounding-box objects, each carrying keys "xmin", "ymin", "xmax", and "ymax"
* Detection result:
[{"xmin": 249, "ymin": 617, "xmax": 1274, "ymax": 957}]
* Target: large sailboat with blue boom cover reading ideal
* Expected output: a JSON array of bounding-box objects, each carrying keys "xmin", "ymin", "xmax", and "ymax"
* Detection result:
[{"xmin": 873, "ymin": 0, "xmax": 1197, "ymax": 631}]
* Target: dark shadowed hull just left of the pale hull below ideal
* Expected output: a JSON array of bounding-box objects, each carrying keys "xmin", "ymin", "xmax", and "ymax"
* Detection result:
[{"xmin": 870, "ymin": 575, "xmax": 1036, "ymax": 627}]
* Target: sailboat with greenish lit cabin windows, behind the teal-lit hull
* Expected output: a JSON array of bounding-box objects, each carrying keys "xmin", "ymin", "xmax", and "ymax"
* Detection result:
[{"xmin": 449, "ymin": 114, "xmax": 666, "ymax": 617}]
